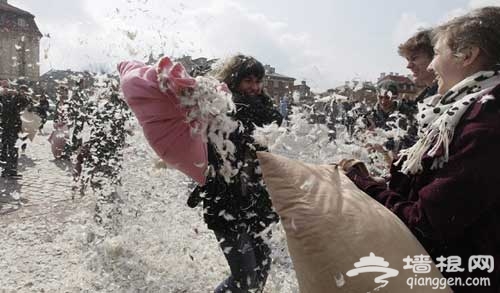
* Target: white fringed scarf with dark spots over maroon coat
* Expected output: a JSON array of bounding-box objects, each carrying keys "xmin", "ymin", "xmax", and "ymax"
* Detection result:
[{"xmin": 395, "ymin": 70, "xmax": 500, "ymax": 174}]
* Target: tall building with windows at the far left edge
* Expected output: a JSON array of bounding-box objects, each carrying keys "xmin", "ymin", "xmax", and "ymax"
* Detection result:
[{"xmin": 0, "ymin": 0, "xmax": 42, "ymax": 80}]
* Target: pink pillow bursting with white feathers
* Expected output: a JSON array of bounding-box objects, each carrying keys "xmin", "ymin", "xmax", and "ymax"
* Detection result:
[{"xmin": 118, "ymin": 58, "xmax": 208, "ymax": 185}]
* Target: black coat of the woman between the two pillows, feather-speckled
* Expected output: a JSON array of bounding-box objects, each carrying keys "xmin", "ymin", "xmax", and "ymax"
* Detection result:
[{"xmin": 188, "ymin": 95, "xmax": 283, "ymax": 233}]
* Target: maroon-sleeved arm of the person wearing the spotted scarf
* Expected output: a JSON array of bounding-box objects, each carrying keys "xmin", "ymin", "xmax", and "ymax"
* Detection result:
[{"xmin": 348, "ymin": 118, "xmax": 500, "ymax": 240}]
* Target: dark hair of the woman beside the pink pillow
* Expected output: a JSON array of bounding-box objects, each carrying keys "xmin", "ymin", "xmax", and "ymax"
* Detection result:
[{"xmin": 216, "ymin": 54, "xmax": 266, "ymax": 91}]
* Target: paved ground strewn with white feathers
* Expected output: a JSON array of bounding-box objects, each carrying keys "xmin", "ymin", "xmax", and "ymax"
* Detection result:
[{"xmin": 0, "ymin": 124, "xmax": 298, "ymax": 293}]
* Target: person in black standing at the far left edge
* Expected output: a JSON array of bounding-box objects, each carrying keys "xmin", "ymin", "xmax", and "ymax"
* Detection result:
[{"xmin": 0, "ymin": 82, "xmax": 31, "ymax": 179}]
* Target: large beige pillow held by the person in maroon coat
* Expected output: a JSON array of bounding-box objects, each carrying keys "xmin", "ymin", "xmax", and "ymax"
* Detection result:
[{"xmin": 258, "ymin": 152, "xmax": 451, "ymax": 293}]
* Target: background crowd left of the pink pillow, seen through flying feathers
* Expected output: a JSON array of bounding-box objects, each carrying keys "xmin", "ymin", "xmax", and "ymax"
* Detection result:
[{"xmin": 0, "ymin": 78, "xmax": 131, "ymax": 227}]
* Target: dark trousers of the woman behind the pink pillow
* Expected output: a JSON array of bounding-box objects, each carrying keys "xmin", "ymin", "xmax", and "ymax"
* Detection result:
[{"xmin": 214, "ymin": 231, "xmax": 271, "ymax": 293}]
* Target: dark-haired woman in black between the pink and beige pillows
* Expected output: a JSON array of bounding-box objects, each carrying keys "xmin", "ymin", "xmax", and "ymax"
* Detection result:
[{"xmin": 188, "ymin": 55, "xmax": 283, "ymax": 293}]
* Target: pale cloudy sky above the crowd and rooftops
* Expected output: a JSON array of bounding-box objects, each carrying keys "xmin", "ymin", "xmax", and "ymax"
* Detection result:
[{"xmin": 8, "ymin": 0, "xmax": 500, "ymax": 91}]
